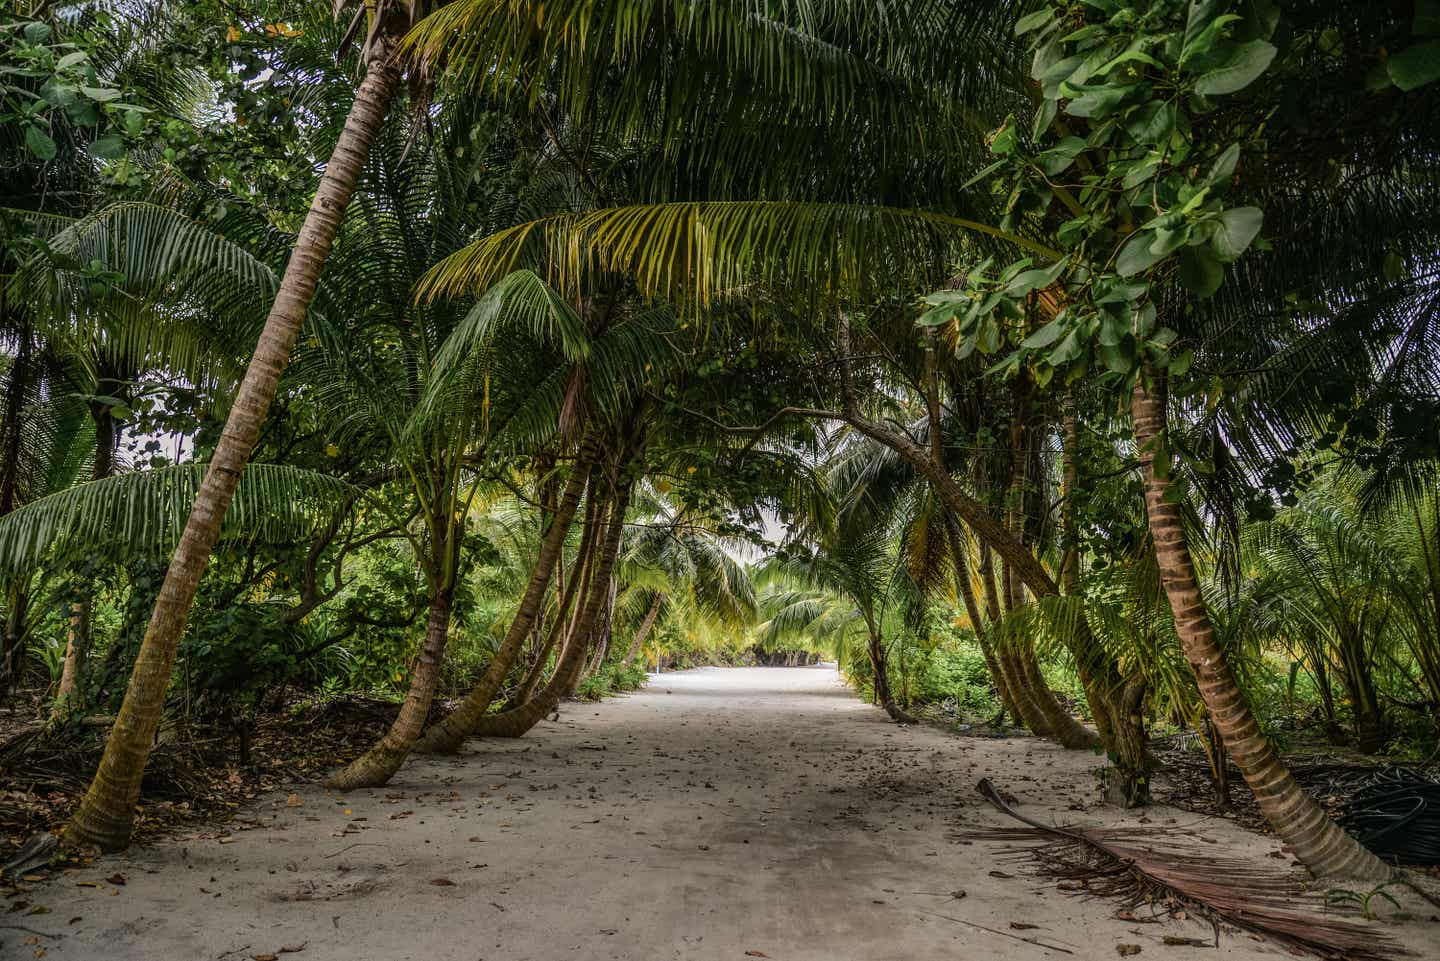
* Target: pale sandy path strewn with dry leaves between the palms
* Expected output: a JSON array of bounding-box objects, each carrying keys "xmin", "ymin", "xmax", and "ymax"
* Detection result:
[{"xmin": 14, "ymin": 667, "xmax": 1440, "ymax": 961}]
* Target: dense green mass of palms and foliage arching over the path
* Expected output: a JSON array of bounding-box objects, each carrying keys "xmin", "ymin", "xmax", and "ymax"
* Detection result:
[{"xmin": 0, "ymin": 0, "xmax": 1440, "ymax": 873}]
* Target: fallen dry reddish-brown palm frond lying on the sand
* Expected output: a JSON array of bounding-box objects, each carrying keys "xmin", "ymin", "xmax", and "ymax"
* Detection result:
[{"xmin": 965, "ymin": 778, "xmax": 1410, "ymax": 961}]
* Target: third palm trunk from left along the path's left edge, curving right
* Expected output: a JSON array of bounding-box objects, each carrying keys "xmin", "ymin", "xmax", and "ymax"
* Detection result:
[{"xmin": 415, "ymin": 446, "xmax": 596, "ymax": 754}]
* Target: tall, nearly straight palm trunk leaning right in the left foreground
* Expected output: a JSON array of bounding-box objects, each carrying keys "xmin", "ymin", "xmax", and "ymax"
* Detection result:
[{"xmin": 65, "ymin": 37, "xmax": 400, "ymax": 850}]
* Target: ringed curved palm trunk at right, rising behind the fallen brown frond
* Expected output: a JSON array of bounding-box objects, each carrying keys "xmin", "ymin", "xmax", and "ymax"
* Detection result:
[{"xmin": 1132, "ymin": 372, "xmax": 1394, "ymax": 880}]
